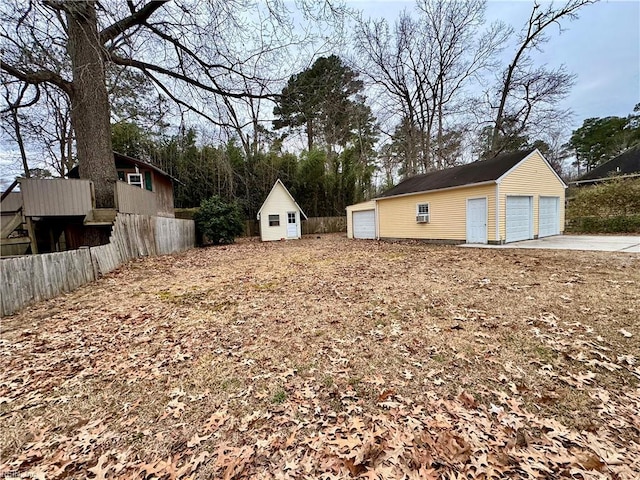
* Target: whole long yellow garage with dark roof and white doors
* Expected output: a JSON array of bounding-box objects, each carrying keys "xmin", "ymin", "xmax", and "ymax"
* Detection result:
[{"xmin": 347, "ymin": 150, "xmax": 567, "ymax": 244}]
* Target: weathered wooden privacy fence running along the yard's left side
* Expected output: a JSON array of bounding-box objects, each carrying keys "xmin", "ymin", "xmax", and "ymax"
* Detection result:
[{"xmin": 0, "ymin": 213, "xmax": 195, "ymax": 315}]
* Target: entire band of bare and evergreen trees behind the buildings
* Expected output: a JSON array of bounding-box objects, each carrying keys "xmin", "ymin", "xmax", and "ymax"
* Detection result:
[{"xmin": 0, "ymin": 0, "xmax": 639, "ymax": 216}]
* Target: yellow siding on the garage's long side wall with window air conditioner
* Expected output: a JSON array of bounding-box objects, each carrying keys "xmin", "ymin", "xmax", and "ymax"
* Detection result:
[{"xmin": 377, "ymin": 184, "xmax": 496, "ymax": 241}]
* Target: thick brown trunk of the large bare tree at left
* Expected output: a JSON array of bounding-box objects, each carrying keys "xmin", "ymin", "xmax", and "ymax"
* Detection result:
[{"xmin": 65, "ymin": 1, "xmax": 117, "ymax": 208}]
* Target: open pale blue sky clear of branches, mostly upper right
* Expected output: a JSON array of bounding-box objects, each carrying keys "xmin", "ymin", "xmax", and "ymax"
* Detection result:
[{"xmin": 356, "ymin": 0, "xmax": 640, "ymax": 130}]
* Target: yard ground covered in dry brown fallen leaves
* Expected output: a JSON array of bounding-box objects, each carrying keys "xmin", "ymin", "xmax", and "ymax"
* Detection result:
[{"xmin": 0, "ymin": 235, "xmax": 640, "ymax": 479}]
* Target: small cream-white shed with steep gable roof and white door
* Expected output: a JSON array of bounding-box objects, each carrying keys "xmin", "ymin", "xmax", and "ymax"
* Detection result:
[{"xmin": 258, "ymin": 179, "xmax": 307, "ymax": 242}]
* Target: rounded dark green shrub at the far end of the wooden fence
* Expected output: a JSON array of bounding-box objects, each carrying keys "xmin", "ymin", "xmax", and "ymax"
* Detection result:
[{"xmin": 193, "ymin": 196, "xmax": 244, "ymax": 245}]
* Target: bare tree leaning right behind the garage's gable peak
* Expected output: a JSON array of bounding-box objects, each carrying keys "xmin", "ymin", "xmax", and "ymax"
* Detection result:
[{"xmin": 486, "ymin": 0, "xmax": 597, "ymax": 157}]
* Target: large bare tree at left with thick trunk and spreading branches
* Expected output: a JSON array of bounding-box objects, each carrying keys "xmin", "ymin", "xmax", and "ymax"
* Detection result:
[{"xmin": 0, "ymin": 0, "xmax": 344, "ymax": 207}]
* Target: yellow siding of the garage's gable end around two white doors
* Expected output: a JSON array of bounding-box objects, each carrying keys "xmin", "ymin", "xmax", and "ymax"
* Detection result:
[{"xmin": 494, "ymin": 151, "xmax": 565, "ymax": 241}]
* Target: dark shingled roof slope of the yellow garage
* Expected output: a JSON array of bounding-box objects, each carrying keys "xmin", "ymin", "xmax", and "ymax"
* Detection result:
[{"xmin": 378, "ymin": 149, "xmax": 535, "ymax": 198}]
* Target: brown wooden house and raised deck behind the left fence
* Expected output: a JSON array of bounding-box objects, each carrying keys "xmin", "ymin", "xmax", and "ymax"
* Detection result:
[{"xmin": 0, "ymin": 153, "xmax": 177, "ymax": 256}]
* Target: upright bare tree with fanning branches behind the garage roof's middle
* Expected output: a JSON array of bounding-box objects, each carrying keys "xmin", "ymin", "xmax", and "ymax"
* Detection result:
[{"xmin": 354, "ymin": 0, "xmax": 508, "ymax": 175}]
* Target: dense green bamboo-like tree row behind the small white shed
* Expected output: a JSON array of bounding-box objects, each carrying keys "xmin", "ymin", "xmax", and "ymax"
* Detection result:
[{"xmin": 113, "ymin": 123, "xmax": 375, "ymax": 218}]
